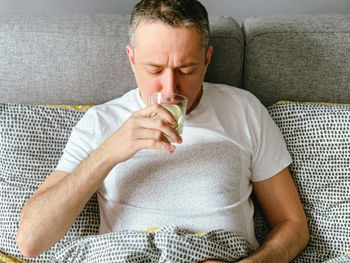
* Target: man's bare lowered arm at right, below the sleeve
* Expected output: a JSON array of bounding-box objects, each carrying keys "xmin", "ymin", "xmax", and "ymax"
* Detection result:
[{"xmin": 240, "ymin": 168, "xmax": 309, "ymax": 263}]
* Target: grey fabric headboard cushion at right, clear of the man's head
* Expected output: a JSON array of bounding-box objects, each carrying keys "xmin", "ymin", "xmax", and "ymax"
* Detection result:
[{"xmin": 243, "ymin": 14, "xmax": 350, "ymax": 106}]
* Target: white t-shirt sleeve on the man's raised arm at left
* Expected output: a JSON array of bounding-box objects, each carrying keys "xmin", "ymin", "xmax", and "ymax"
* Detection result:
[{"xmin": 56, "ymin": 108, "xmax": 96, "ymax": 173}]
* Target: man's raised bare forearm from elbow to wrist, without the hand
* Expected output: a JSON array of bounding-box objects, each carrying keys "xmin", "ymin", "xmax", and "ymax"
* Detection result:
[{"xmin": 16, "ymin": 152, "xmax": 115, "ymax": 257}]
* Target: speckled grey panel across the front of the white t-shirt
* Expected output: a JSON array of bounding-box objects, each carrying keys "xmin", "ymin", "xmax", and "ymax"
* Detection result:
[{"xmin": 101, "ymin": 141, "xmax": 242, "ymax": 212}]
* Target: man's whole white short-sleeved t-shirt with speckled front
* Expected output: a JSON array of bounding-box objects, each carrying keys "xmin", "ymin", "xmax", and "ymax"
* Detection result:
[{"xmin": 56, "ymin": 83, "xmax": 291, "ymax": 248}]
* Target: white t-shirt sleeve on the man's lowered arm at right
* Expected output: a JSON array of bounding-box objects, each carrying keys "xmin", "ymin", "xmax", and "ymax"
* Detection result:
[{"xmin": 250, "ymin": 95, "xmax": 292, "ymax": 182}]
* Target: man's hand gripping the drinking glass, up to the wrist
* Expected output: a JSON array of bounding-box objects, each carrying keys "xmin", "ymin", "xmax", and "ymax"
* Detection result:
[{"xmin": 101, "ymin": 104, "xmax": 182, "ymax": 167}]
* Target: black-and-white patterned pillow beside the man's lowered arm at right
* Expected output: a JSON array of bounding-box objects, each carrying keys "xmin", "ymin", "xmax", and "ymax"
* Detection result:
[{"xmin": 259, "ymin": 102, "xmax": 350, "ymax": 262}]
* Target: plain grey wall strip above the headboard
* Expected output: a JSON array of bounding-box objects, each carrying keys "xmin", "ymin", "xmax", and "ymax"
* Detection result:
[{"xmin": 0, "ymin": 0, "xmax": 350, "ymax": 23}]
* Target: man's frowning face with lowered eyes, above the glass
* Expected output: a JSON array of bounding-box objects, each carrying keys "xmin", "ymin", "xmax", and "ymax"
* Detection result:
[{"xmin": 126, "ymin": 21, "xmax": 212, "ymax": 110}]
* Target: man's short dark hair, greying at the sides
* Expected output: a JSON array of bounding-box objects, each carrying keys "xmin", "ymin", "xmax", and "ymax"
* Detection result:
[{"xmin": 129, "ymin": 0, "xmax": 210, "ymax": 48}]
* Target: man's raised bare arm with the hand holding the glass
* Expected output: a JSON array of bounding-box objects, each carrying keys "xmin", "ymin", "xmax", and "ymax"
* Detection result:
[{"xmin": 16, "ymin": 104, "xmax": 181, "ymax": 257}]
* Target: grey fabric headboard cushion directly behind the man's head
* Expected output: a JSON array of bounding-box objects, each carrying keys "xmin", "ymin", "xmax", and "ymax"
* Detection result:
[{"xmin": 0, "ymin": 14, "xmax": 244, "ymax": 105}]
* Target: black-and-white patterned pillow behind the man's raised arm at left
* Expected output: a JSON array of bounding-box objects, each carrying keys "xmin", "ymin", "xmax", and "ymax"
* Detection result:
[{"xmin": 0, "ymin": 104, "xmax": 99, "ymax": 262}]
